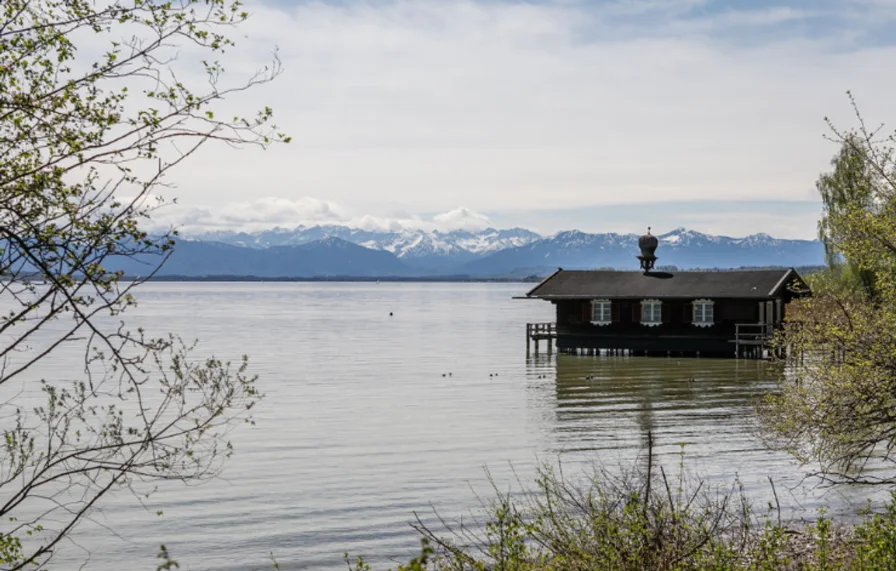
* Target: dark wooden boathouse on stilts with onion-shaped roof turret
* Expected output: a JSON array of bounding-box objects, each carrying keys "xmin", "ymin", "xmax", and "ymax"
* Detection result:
[{"xmin": 524, "ymin": 229, "xmax": 811, "ymax": 358}]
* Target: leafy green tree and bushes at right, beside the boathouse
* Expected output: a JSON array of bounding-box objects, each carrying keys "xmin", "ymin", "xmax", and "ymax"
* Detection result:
[{"xmin": 762, "ymin": 95, "xmax": 896, "ymax": 484}]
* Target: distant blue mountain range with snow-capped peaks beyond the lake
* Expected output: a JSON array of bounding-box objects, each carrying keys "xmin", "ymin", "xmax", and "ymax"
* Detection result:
[{"xmin": 112, "ymin": 226, "xmax": 824, "ymax": 278}]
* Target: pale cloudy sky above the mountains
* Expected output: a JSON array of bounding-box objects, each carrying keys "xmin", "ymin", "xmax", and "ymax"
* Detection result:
[{"xmin": 149, "ymin": 0, "xmax": 896, "ymax": 237}]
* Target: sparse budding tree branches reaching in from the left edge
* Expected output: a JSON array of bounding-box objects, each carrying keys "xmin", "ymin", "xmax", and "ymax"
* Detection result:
[{"xmin": 0, "ymin": 0, "xmax": 288, "ymax": 569}]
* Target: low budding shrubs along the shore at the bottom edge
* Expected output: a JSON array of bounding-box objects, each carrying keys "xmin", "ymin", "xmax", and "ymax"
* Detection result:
[{"xmin": 346, "ymin": 446, "xmax": 896, "ymax": 571}]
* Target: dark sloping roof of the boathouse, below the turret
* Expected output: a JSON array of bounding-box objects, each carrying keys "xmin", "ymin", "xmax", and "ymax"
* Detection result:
[{"xmin": 526, "ymin": 269, "xmax": 798, "ymax": 299}]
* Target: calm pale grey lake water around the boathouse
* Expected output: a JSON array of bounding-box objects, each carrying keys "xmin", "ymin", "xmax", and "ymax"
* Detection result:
[{"xmin": 5, "ymin": 283, "xmax": 876, "ymax": 570}]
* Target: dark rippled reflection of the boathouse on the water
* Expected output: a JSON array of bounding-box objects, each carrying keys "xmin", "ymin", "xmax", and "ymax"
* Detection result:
[{"xmin": 544, "ymin": 355, "xmax": 771, "ymax": 450}]
